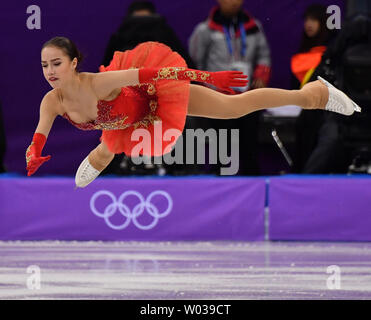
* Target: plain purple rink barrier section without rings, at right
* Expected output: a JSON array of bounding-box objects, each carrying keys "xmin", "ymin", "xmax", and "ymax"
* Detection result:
[{"xmin": 268, "ymin": 176, "xmax": 371, "ymax": 241}]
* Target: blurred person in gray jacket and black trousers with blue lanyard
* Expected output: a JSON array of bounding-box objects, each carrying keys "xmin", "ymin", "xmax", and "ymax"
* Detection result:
[{"xmin": 189, "ymin": 0, "xmax": 271, "ymax": 175}]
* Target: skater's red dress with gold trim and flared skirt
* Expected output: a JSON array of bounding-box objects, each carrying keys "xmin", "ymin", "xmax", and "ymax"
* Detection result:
[{"xmin": 63, "ymin": 42, "xmax": 190, "ymax": 156}]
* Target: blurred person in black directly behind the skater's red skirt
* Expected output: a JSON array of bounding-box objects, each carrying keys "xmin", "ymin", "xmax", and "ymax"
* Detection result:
[{"xmin": 102, "ymin": 1, "xmax": 195, "ymax": 175}]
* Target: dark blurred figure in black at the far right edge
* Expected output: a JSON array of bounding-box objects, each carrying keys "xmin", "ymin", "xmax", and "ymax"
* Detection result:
[{"xmin": 312, "ymin": 0, "xmax": 371, "ymax": 174}]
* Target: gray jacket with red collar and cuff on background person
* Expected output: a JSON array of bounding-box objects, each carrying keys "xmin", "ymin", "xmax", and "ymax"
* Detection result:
[{"xmin": 189, "ymin": 7, "xmax": 271, "ymax": 84}]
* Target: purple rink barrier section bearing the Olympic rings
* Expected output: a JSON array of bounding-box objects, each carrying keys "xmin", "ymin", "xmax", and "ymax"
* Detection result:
[{"xmin": 0, "ymin": 176, "xmax": 266, "ymax": 241}]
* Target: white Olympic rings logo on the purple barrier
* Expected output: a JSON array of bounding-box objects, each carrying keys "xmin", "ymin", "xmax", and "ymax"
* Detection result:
[{"xmin": 90, "ymin": 190, "xmax": 173, "ymax": 230}]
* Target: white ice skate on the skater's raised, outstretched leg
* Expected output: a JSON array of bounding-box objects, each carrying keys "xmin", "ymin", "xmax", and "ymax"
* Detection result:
[{"xmin": 317, "ymin": 76, "xmax": 361, "ymax": 116}]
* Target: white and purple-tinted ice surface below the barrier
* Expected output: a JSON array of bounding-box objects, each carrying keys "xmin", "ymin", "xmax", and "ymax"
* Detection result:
[{"xmin": 0, "ymin": 241, "xmax": 371, "ymax": 300}]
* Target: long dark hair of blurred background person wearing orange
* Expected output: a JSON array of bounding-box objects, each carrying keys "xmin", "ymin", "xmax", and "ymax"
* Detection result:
[{"xmin": 299, "ymin": 4, "xmax": 331, "ymax": 52}]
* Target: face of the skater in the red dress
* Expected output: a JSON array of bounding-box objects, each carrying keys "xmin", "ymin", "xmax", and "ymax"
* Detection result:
[{"xmin": 41, "ymin": 46, "xmax": 77, "ymax": 88}]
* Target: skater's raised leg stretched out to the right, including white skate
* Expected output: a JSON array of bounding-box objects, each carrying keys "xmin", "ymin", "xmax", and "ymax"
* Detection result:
[{"xmin": 188, "ymin": 80, "xmax": 360, "ymax": 119}]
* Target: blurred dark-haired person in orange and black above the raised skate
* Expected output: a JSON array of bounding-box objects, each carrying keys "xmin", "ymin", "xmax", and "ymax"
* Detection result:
[{"xmin": 291, "ymin": 4, "xmax": 344, "ymax": 174}]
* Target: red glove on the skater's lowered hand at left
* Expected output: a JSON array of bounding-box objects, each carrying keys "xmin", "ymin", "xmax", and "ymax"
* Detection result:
[{"xmin": 26, "ymin": 132, "xmax": 51, "ymax": 176}]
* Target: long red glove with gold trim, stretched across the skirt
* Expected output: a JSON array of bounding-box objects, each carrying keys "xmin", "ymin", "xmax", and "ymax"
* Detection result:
[{"xmin": 139, "ymin": 67, "xmax": 249, "ymax": 93}]
